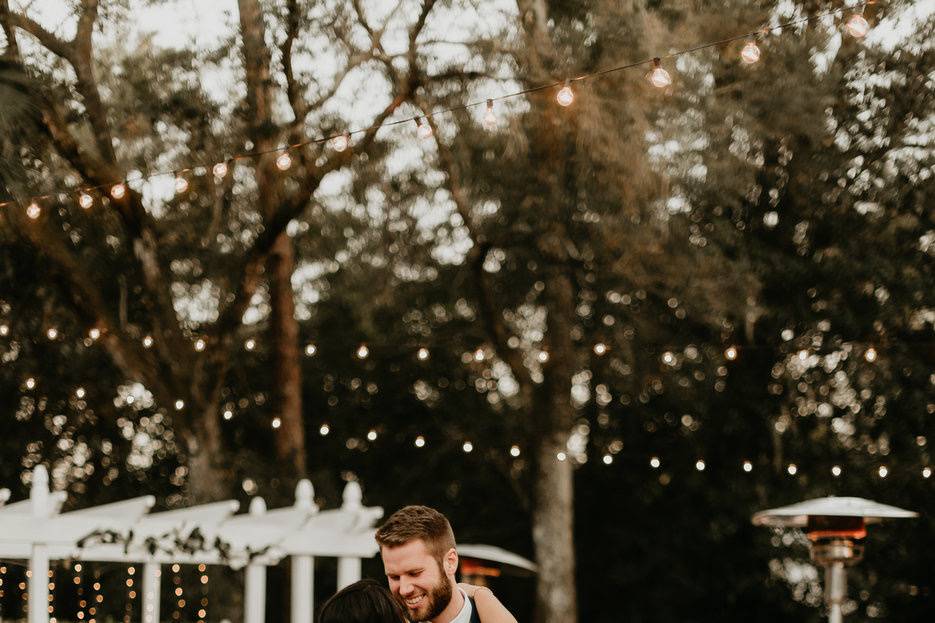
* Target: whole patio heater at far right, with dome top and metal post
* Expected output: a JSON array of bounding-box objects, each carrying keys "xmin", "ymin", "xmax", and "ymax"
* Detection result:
[{"xmin": 753, "ymin": 496, "xmax": 919, "ymax": 623}]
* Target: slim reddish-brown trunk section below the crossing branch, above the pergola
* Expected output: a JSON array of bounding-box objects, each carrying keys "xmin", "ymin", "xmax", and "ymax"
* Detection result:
[{"xmin": 267, "ymin": 234, "xmax": 307, "ymax": 478}]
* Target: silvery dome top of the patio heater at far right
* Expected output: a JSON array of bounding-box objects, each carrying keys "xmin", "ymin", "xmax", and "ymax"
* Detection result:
[{"xmin": 753, "ymin": 496, "xmax": 919, "ymax": 528}]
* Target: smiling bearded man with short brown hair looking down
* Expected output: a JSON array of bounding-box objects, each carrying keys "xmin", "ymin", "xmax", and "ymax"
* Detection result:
[{"xmin": 376, "ymin": 506, "xmax": 516, "ymax": 623}]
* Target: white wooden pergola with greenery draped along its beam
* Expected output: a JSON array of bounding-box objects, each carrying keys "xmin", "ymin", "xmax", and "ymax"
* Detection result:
[{"xmin": 0, "ymin": 465, "xmax": 383, "ymax": 623}]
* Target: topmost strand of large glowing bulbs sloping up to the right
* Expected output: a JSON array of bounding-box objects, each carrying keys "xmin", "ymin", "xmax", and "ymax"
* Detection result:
[{"xmin": 0, "ymin": 0, "xmax": 872, "ymax": 212}]
